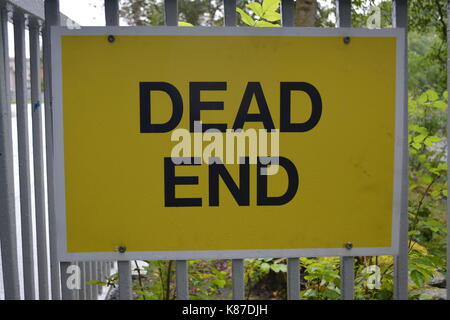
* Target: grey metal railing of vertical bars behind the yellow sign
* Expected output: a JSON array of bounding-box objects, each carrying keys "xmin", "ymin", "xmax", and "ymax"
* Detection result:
[{"xmin": 0, "ymin": 0, "xmax": 442, "ymax": 300}]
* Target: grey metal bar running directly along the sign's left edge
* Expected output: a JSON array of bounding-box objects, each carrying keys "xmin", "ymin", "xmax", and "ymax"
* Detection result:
[{"xmin": 43, "ymin": 0, "xmax": 61, "ymax": 300}]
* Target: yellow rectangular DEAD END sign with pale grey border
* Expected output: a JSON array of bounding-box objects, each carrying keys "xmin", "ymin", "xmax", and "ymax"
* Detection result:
[{"xmin": 52, "ymin": 27, "xmax": 405, "ymax": 261}]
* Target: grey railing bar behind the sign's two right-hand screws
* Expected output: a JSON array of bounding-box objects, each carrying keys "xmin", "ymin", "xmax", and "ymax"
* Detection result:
[{"xmin": 336, "ymin": 0, "xmax": 355, "ymax": 300}]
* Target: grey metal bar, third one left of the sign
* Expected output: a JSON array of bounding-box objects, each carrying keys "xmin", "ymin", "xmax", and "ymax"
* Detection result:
[{"xmin": 13, "ymin": 10, "xmax": 36, "ymax": 300}]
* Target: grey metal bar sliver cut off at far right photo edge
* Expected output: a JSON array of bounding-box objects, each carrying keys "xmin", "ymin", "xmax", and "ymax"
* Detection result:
[{"xmin": 447, "ymin": 0, "xmax": 450, "ymax": 300}]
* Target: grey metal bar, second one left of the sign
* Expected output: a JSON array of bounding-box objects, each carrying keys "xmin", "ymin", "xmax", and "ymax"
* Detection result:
[{"xmin": 28, "ymin": 18, "xmax": 49, "ymax": 300}]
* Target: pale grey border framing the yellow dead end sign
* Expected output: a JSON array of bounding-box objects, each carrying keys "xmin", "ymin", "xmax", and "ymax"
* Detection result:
[{"xmin": 50, "ymin": 26, "xmax": 407, "ymax": 261}]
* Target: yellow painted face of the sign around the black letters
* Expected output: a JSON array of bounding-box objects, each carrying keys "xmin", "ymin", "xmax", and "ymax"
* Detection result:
[{"xmin": 61, "ymin": 36, "xmax": 396, "ymax": 253}]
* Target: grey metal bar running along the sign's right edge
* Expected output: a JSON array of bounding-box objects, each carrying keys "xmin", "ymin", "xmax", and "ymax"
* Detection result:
[{"xmin": 392, "ymin": 0, "xmax": 409, "ymax": 300}]
